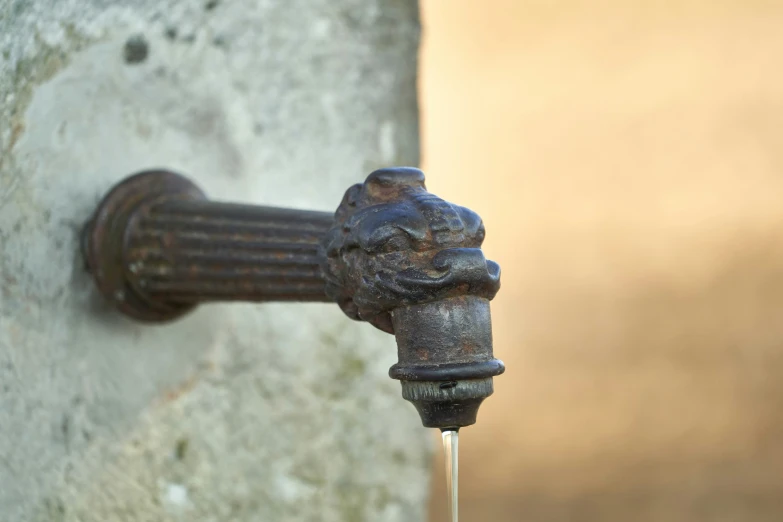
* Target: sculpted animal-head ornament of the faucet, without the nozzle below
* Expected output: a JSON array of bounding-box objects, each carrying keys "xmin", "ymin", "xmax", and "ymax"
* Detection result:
[{"xmin": 322, "ymin": 168, "xmax": 500, "ymax": 333}]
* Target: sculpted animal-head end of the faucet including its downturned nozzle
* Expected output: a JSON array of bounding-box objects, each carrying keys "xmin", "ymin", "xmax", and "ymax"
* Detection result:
[{"xmin": 323, "ymin": 168, "xmax": 505, "ymax": 428}]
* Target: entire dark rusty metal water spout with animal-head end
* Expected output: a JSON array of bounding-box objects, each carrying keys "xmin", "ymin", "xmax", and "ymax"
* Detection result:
[{"xmin": 82, "ymin": 167, "xmax": 504, "ymax": 430}]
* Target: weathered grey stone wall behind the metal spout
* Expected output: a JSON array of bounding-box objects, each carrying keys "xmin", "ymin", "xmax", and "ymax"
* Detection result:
[{"xmin": 0, "ymin": 0, "xmax": 429, "ymax": 522}]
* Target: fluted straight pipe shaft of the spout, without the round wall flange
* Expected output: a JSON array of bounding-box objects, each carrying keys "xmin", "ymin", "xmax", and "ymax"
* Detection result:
[{"xmin": 124, "ymin": 200, "xmax": 333, "ymax": 303}]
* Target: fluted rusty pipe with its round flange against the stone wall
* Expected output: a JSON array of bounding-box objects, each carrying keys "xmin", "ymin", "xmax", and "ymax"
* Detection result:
[{"xmin": 85, "ymin": 171, "xmax": 333, "ymax": 321}]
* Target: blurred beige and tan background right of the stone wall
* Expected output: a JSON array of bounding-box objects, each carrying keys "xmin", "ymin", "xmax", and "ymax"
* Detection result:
[{"xmin": 421, "ymin": 0, "xmax": 783, "ymax": 522}]
